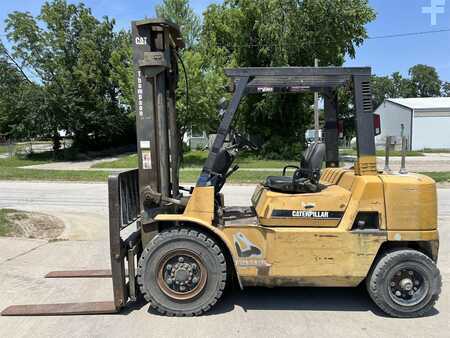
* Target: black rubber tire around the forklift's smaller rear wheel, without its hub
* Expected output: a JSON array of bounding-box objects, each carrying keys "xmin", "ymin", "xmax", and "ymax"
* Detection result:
[{"xmin": 366, "ymin": 249, "xmax": 442, "ymax": 318}]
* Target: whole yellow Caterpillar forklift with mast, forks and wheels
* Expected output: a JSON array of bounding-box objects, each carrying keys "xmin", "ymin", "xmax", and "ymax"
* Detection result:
[{"xmin": 2, "ymin": 19, "xmax": 442, "ymax": 317}]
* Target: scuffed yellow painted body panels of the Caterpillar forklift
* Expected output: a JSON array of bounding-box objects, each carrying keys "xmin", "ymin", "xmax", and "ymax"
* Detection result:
[{"xmin": 156, "ymin": 166, "xmax": 439, "ymax": 286}]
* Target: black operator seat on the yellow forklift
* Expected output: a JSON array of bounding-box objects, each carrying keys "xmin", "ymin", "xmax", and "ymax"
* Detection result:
[{"xmin": 264, "ymin": 142, "xmax": 325, "ymax": 194}]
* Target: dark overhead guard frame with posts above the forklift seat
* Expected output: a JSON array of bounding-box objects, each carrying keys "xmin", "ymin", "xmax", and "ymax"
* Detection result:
[{"xmin": 197, "ymin": 67, "xmax": 376, "ymax": 186}]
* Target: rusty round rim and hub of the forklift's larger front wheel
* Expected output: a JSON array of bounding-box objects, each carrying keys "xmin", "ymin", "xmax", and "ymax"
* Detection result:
[{"xmin": 158, "ymin": 250, "xmax": 207, "ymax": 300}]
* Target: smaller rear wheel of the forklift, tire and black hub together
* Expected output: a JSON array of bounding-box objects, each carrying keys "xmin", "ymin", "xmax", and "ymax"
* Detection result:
[{"xmin": 366, "ymin": 249, "xmax": 442, "ymax": 318}]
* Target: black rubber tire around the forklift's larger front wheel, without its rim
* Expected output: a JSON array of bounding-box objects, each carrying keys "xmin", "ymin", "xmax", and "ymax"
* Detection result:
[{"xmin": 137, "ymin": 227, "xmax": 227, "ymax": 316}]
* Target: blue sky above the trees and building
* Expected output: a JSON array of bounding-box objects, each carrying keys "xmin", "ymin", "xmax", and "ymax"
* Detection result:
[{"xmin": 0, "ymin": 0, "xmax": 450, "ymax": 81}]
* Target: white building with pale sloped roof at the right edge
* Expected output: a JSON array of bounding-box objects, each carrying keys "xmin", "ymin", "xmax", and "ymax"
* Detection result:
[{"xmin": 375, "ymin": 97, "xmax": 450, "ymax": 150}]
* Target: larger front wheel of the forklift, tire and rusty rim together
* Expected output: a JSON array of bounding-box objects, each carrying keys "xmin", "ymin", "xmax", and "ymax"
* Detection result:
[{"xmin": 137, "ymin": 228, "xmax": 227, "ymax": 316}]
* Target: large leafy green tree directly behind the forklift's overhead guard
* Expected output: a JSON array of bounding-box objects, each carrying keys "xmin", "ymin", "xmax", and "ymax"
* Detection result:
[{"xmin": 201, "ymin": 0, "xmax": 375, "ymax": 157}]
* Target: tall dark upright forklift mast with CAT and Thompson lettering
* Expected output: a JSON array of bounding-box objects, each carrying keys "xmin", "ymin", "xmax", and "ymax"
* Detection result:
[{"xmin": 132, "ymin": 19, "xmax": 184, "ymax": 219}]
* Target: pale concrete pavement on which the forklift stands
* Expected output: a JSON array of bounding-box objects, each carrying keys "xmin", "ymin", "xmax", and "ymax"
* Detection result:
[{"xmin": 0, "ymin": 182, "xmax": 450, "ymax": 337}]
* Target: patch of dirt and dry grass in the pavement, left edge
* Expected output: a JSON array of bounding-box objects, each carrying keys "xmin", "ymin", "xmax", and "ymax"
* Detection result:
[{"xmin": 0, "ymin": 209, "xmax": 64, "ymax": 240}]
